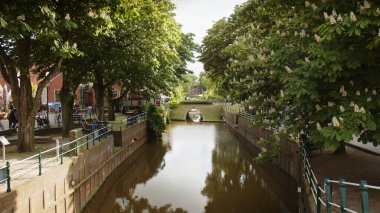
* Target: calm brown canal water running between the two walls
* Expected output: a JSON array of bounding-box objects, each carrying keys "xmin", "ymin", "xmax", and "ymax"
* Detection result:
[{"xmin": 83, "ymin": 122, "xmax": 298, "ymax": 213}]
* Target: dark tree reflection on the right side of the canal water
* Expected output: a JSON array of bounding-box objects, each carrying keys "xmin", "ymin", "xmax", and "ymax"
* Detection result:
[{"xmin": 202, "ymin": 125, "xmax": 289, "ymax": 212}]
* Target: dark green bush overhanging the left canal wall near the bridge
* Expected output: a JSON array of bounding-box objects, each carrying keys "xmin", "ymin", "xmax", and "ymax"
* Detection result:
[{"xmin": 147, "ymin": 104, "xmax": 166, "ymax": 141}]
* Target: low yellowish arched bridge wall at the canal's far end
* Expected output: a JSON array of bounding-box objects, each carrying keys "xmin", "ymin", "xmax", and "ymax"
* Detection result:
[{"xmin": 170, "ymin": 104, "xmax": 223, "ymax": 121}]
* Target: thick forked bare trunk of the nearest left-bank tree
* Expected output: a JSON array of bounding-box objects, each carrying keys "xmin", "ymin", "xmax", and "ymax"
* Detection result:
[{"xmin": 0, "ymin": 36, "xmax": 63, "ymax": 152}]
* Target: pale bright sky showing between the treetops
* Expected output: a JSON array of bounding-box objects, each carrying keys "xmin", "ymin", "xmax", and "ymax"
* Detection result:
[{"xmin": 172, "ymin": 0, "xmax": 246, "ymax": 76}]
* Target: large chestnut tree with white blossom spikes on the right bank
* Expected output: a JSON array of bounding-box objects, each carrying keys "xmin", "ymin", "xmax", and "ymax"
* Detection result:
[{"xmin": 203, "ymin": 1, "xmax": 380, "ymax": 156}]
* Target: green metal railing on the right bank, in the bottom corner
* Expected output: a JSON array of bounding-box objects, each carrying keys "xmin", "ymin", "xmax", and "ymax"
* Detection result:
[{"xmin": 301, "ymin": 146, "xmax": 380, "ymax": 213}]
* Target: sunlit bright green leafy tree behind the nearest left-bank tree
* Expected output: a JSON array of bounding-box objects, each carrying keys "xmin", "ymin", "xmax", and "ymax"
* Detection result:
[{"xmin": 62, "ymin": 0, "xmax": 197, "ymax": 136}]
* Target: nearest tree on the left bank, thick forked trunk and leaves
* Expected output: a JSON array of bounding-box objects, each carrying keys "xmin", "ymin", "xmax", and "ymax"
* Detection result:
[{"xmin": 0, "ymin": 1, "xmax": 84, "ymax": 152}]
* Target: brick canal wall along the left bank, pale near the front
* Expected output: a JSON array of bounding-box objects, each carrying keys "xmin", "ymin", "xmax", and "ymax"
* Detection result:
[{"xmin": 0, "ymin": 121, "xmax": 147, "ymax": 213}]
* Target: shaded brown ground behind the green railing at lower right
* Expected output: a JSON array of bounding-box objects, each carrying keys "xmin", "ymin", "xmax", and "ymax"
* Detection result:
[{"xmin": 310, "ymin": 146, "xmax": 380, "ymax": 212}]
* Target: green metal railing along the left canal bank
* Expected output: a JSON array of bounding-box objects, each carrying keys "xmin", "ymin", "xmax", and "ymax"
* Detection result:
[{"xmin": 0, "ymin": 124, "xmax": 112, "ymax": 192}]
